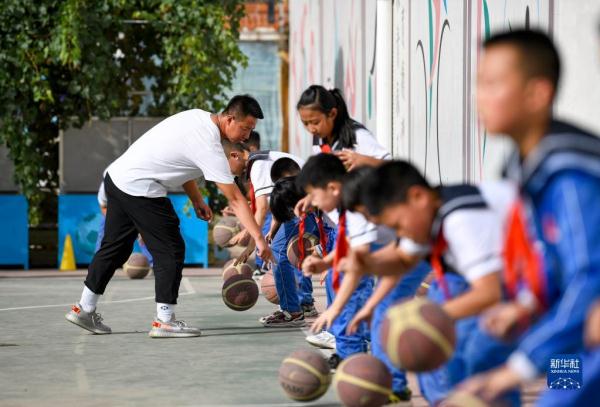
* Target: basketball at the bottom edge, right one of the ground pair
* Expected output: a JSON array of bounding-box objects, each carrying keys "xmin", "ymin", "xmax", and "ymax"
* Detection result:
[{"xmin": 333, "ymin": 353, "xmax": 392, "ymax": 407}]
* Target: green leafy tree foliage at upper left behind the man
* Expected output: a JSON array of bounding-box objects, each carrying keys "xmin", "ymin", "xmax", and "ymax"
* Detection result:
[{"xmin": 0, "ymin": 0, "xmax": 246, "ymax": 224}]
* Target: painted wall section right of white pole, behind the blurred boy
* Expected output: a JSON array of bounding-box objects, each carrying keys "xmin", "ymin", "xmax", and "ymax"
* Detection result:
[{"xmin": 393, "ymin": 0, "xmax": 600, "ymax": 182}]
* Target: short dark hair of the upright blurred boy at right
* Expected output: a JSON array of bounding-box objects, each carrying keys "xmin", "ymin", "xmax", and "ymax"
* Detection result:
[{"xmin": 483, "ymin": 29, "xmax": 560, "ymax": 89}]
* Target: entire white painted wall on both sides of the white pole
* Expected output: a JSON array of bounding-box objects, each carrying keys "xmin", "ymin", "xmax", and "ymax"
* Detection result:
[{"xmin": 289, "ymin": 0, "xmax": 600, "ymax": 183}]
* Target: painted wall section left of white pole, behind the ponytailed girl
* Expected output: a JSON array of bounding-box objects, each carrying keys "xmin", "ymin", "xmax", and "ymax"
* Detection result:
[{"xmin": 289, "ymin": 0, "xmax": 376, "ymax": 156}]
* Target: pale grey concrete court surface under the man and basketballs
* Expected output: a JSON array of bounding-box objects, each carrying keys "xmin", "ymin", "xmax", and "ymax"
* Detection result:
[{"xmin": 0, "ymin": 269, "xmax": 536, "ymax": 407}]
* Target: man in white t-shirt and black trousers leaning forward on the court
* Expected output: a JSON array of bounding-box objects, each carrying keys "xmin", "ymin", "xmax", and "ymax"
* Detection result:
[{"xmin": 66, "ymin": 95, "xmax": 272, "ymax": 338}]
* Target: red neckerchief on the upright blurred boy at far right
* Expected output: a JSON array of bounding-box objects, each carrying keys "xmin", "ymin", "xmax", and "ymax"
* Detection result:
[{"xmin": 504, "ymin": 201, "xmax": 547, "ymax": 309}]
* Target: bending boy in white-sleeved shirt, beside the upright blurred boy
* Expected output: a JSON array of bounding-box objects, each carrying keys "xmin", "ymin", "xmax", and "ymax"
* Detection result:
[{"xmin": 330, "ymin": 161, "xmax": 514, "ymax": 405}]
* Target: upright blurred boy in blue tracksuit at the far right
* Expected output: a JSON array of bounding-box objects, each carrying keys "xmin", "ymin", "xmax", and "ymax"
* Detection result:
[{"xmin": 464, "ymin": 30, "xmax": 600, "ymax": 406}]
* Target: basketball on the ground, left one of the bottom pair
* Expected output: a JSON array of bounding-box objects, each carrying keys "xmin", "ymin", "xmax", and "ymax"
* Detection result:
[{"xmin": 279, "ymin": 349, "xmax": 331, "ymax": 401}]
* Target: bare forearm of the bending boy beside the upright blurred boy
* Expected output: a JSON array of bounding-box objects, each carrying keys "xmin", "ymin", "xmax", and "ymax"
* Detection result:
[{"xmin": 443, "ymin": 272, "xmax": 502, "ymax": 320}]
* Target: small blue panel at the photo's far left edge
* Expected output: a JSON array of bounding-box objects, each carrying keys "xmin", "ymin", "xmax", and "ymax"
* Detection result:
[{"xmin": 0, "ymin": 195, "xmax": 29, "ymax": 269}]
